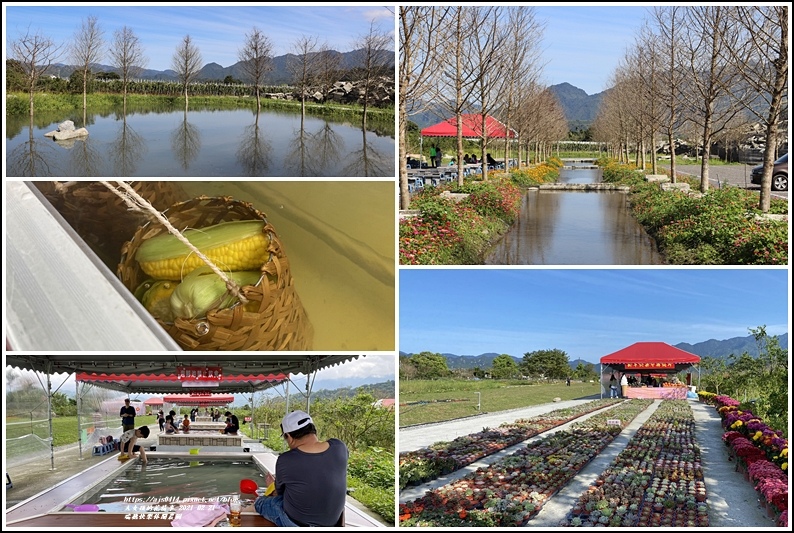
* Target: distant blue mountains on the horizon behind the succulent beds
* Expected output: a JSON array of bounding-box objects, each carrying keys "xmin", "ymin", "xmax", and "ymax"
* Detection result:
[{"xmin": 400, "ymin": 333, "xmax": 788, "ymax": 370}]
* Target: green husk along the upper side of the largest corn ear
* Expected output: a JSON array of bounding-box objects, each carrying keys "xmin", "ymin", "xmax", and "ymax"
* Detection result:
[{"xmin": 135, "ymin": 220, "xmax": 265, "ymax": 263}]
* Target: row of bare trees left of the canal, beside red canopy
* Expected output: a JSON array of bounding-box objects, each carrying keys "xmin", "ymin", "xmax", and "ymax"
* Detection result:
[{"xmin": 398, "ymin": 6, "xmax": 568, "ymax": 209}]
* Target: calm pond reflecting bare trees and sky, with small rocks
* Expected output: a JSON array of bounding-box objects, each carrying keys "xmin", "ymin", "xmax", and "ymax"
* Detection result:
[{"xmin": 6, "ymin": 107, "xmax": 395, "ymax": 178}]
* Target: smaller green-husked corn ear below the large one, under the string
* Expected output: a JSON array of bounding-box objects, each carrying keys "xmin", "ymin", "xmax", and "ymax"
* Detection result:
[{"xmin": 170, "ymin": 266, "xmax": 262, "ymax": 319}]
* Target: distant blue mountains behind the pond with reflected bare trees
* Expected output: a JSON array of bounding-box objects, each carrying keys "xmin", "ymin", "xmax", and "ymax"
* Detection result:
[{"xmin": 48, "ymin": 46, "xmax": 394, "ymax": 85}]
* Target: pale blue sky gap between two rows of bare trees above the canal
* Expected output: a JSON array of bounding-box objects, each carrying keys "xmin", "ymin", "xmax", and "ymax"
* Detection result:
[{"xmin": 535, "ymin": 4, "xmax": 651, "ymax": 94}]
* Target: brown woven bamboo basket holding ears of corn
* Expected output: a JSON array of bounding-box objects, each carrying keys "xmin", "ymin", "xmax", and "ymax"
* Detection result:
[{"xmin": 117, "ymin": 196, "xmax": 314, "ymax": 351}]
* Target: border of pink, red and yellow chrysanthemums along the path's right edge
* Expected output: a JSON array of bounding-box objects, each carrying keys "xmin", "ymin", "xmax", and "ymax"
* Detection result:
[{"xmin": 714, "ymin": 396, "xmax": 788, "ymax": 527}]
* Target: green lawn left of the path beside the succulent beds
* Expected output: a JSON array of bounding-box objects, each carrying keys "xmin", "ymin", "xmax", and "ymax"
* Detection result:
[{"xmin": 399, "ymin": 380, "xmax": 600, "ymax": 427}]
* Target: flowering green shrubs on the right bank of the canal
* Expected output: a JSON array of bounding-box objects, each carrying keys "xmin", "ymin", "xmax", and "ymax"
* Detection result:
[{"xmin": 599, "ymin": 159, "xmax": 788, "ymax": 265}]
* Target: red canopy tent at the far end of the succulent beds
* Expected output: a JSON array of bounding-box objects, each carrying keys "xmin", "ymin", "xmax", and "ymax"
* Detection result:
[{"xmin": 601, "ymin": 342, "xmax": 700, "ymax": 398}]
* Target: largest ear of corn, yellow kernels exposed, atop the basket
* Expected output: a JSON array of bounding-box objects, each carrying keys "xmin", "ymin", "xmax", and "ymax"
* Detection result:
[{"xmin": 135, "ymin": 220, "xmax": 270, "ymax": 280}]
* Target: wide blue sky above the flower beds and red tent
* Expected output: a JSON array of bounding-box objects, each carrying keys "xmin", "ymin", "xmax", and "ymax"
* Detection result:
[{"xmin": 399, "ymin": 268, "xmax": 790, "ymax": 363}]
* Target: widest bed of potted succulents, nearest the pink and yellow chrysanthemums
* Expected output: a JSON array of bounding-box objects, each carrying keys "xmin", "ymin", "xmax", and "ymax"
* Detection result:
[{"xmin": 560, "ymin": 400, "xmax": 709, "ymax": 527}]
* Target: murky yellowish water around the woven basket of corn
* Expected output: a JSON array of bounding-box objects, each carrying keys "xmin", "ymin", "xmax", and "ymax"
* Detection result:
[{"xmin": 38, "ymin": 181, "xmax": 395, "ymax": 351}]
